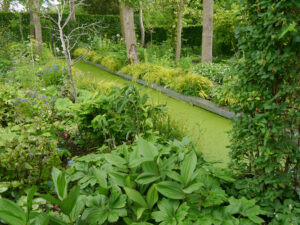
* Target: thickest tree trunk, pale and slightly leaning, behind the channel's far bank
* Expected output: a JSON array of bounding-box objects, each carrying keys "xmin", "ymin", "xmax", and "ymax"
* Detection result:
[{"xmin": 120, "ymin": 3, "xmax": 139, "ymax": 64}]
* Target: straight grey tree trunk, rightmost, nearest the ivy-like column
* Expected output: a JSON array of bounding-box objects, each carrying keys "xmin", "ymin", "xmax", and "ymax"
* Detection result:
[{"xmin": 201, "ymin": 0, "xmax": 214, "ymax": 63}]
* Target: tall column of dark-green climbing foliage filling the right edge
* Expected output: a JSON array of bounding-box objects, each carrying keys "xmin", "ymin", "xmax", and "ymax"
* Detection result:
[{"xmin": 231, "ymin": 0, "xmax": 300, "ymax": 224}]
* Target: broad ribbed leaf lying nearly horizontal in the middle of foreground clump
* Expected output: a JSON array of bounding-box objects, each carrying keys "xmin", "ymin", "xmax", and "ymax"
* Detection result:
[{"xmin": 156, "ymin": 181, "xmax": 185, "ymax": 199}]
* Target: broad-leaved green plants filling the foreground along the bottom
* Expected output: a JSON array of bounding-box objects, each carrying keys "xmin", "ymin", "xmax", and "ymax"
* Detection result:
[{"xmin": 0, "ymin": 138, "xmax": 264, "ymax": 225}]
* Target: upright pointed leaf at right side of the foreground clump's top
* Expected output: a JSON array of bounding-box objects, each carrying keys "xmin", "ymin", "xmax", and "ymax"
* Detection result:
[{"xmin": 181, "ymin": 151, "xmax": 197, "ymax": 185}]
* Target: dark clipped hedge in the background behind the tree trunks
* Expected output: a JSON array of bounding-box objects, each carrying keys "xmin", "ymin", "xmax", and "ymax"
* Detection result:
[{"xmin": 0, "ymin": 13, "xmax": 235, "ymax": 55}]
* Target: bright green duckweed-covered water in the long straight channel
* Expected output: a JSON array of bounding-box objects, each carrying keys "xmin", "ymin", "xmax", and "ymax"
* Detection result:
[{"xmin": 75, "ymin": 62, "xmax": 232, "ymax": 165}]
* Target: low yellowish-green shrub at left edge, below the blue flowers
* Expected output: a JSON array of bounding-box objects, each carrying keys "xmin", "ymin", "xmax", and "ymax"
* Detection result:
[{"xmin": 0, "ymin": 120, "xmax": 61, "ymax": 196}]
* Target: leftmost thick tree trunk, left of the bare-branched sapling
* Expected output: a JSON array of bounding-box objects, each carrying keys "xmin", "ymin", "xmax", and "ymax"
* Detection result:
[{"xmin": 33, "ymin": 0, "xmax": 43, "ymax": 55}]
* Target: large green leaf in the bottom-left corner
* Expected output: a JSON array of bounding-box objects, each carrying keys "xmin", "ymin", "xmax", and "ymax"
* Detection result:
[{"xmin": 0, "ymin": 199, "xmax": 26, "ymax": 225}]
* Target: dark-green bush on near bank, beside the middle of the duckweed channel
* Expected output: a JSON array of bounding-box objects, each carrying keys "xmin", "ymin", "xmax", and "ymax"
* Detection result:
[{"xmin": 56, "ymin": 86, "xmax": 178, "ymax": 148}]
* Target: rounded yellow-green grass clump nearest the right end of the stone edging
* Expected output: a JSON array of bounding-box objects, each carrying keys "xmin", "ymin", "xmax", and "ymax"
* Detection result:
[{"xmin": 170, "ymin": 74, "xmax": 213, "ymax": 99}]
